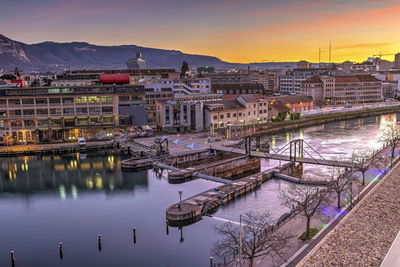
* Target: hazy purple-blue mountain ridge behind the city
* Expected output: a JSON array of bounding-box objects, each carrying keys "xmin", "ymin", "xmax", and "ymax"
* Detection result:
[{"xmin": 0, "ymin": 34, "xmax": 295, "ymax": 73}]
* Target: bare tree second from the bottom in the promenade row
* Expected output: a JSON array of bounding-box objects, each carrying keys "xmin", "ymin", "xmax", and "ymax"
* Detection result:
[{"xmin": 279, "ymin": 184, "xmax": 329, "ymax": 238}]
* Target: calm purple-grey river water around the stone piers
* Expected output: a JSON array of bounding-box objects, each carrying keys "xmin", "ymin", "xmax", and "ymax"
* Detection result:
[{"xmin": 0, "ymin": 115, "xmax": 396, "ymax": 267}]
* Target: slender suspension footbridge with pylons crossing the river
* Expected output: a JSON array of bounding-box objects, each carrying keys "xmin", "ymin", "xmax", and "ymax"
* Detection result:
[{"xmin": 212, "ymin": 137, "xmax": 362, "ymax": 169}]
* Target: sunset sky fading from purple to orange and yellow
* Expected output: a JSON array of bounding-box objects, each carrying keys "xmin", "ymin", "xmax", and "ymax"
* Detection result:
[{"xmin": 0, "ymin": 0, "xmax": 400, "ymax": 63}]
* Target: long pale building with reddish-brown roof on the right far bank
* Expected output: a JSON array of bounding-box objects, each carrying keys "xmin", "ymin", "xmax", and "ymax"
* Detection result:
[{"xmin": 301, "ymin": 75, "xmax": 383, "ymax": 105}]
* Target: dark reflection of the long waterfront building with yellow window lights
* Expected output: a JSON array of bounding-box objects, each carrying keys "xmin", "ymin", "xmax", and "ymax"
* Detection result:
[{"xmin": 0, "ymin": 152, "xmax": 148, "ymax": 197}]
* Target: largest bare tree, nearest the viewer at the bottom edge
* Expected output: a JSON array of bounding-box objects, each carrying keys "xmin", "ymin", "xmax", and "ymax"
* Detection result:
[{"xmin": 212, "ymin": 212, "xmax": 291, "ymax": 267}]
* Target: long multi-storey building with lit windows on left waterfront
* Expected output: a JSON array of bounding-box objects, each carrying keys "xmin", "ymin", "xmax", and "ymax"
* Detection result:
[{"xmin": 0, "ymin": 85, "xmax": 147, "ymax": 143}]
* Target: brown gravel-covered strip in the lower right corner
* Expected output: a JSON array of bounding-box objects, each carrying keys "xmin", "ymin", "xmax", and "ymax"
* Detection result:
[{"xmin": 298, "ymin": 160, "xmax": 400, "ymax": 266}]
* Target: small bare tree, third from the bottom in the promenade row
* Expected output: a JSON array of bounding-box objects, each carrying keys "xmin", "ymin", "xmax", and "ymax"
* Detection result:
[{"xmin": 329, "ymin": 164, "xmax": 353, "ymax": 209}]
